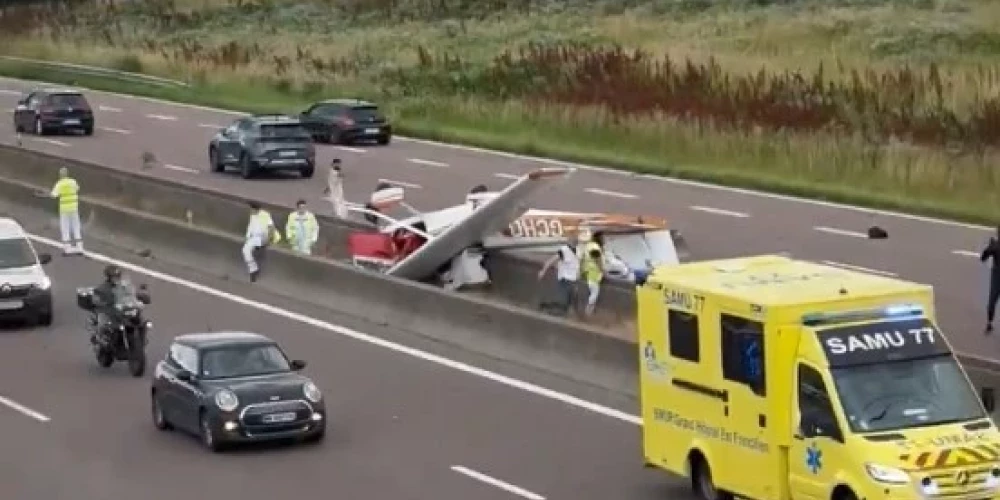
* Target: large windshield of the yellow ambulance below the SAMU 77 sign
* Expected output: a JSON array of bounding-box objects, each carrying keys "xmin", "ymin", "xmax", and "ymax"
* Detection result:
[{"xmin": 833, "ymin": 356, "xmax": 986, "ymax": 432}]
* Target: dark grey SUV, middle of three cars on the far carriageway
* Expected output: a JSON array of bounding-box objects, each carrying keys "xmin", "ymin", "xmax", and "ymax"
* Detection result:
[{"xmin": 208, "ymin": 115, "xmax": 316, "ymax": 179}]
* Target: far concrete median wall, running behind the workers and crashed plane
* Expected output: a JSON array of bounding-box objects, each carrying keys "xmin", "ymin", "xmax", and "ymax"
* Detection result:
[{"xmin": 0, "ymin": 145, "xmax": 636, "ymax": 331}]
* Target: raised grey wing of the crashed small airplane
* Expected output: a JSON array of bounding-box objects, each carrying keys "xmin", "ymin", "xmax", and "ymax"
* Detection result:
[{"xmin": 388, "ymin": 168, "xmax": 576, "ymax": 280}]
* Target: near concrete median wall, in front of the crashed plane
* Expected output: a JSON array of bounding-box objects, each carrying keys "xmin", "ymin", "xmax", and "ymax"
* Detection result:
[{"xmin": 0, "ymin": 158, "xmax": 638, "ymax": 396}]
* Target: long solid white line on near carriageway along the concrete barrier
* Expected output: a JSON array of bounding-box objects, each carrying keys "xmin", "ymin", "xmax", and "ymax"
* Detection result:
[{"xmin": 28, "ymin": 234, "xmax": 642, "ymax": 425}]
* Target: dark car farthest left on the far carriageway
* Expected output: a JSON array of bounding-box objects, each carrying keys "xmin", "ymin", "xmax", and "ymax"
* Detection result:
[{"xmin": 14, "ymin": 89, "xmax": 94, "ymax": 135}]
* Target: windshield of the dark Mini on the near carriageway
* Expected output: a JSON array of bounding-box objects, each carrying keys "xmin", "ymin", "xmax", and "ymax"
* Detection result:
[{"xmin": 201, "ymin": 344, "xmax": 291, "ymax": 379}]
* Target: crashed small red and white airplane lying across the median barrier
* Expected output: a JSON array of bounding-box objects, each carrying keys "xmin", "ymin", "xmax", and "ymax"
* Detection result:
[{"xmin": 335, "ymin": 168, "xmax": 684, "ymax": 289}]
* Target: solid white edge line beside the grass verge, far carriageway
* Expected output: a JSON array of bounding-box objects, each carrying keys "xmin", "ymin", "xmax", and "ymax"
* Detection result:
[{"xmin": 0, "ymin": 77, "xmax": 984, "ymax": 231}]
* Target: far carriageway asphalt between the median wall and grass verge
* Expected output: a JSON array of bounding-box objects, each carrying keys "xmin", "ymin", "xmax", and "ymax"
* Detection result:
[{"xmin": 0, "ymin": 79, "xmax": 1000, "ymax": 357}]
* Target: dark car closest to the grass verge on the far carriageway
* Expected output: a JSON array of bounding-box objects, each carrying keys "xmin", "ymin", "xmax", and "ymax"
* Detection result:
[{"xmin": 299, "ymin": 99, "xmax": 392, "ymax": 144}]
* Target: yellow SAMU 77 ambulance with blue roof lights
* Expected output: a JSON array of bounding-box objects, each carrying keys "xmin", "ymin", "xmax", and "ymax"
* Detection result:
[{"xmin": 637, "ymin": 256, "xmax": 1000, "ymax": 500}]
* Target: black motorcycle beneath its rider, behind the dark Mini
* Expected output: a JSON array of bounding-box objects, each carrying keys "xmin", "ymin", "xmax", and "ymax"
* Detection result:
[{"xmin": 76, "ymin": 283, "xmax": 153, "ymax": 377}]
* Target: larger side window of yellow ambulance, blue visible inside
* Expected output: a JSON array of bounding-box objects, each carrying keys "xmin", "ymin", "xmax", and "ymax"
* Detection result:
[{"xmin": 719, "ymin": 314, "xmax": 767, "ymax": 397}]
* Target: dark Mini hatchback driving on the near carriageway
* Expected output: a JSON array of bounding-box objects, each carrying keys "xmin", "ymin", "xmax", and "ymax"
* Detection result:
[{"xmin": 151, "ymin": 332, "xmax": 326, "ymax": 451}]
